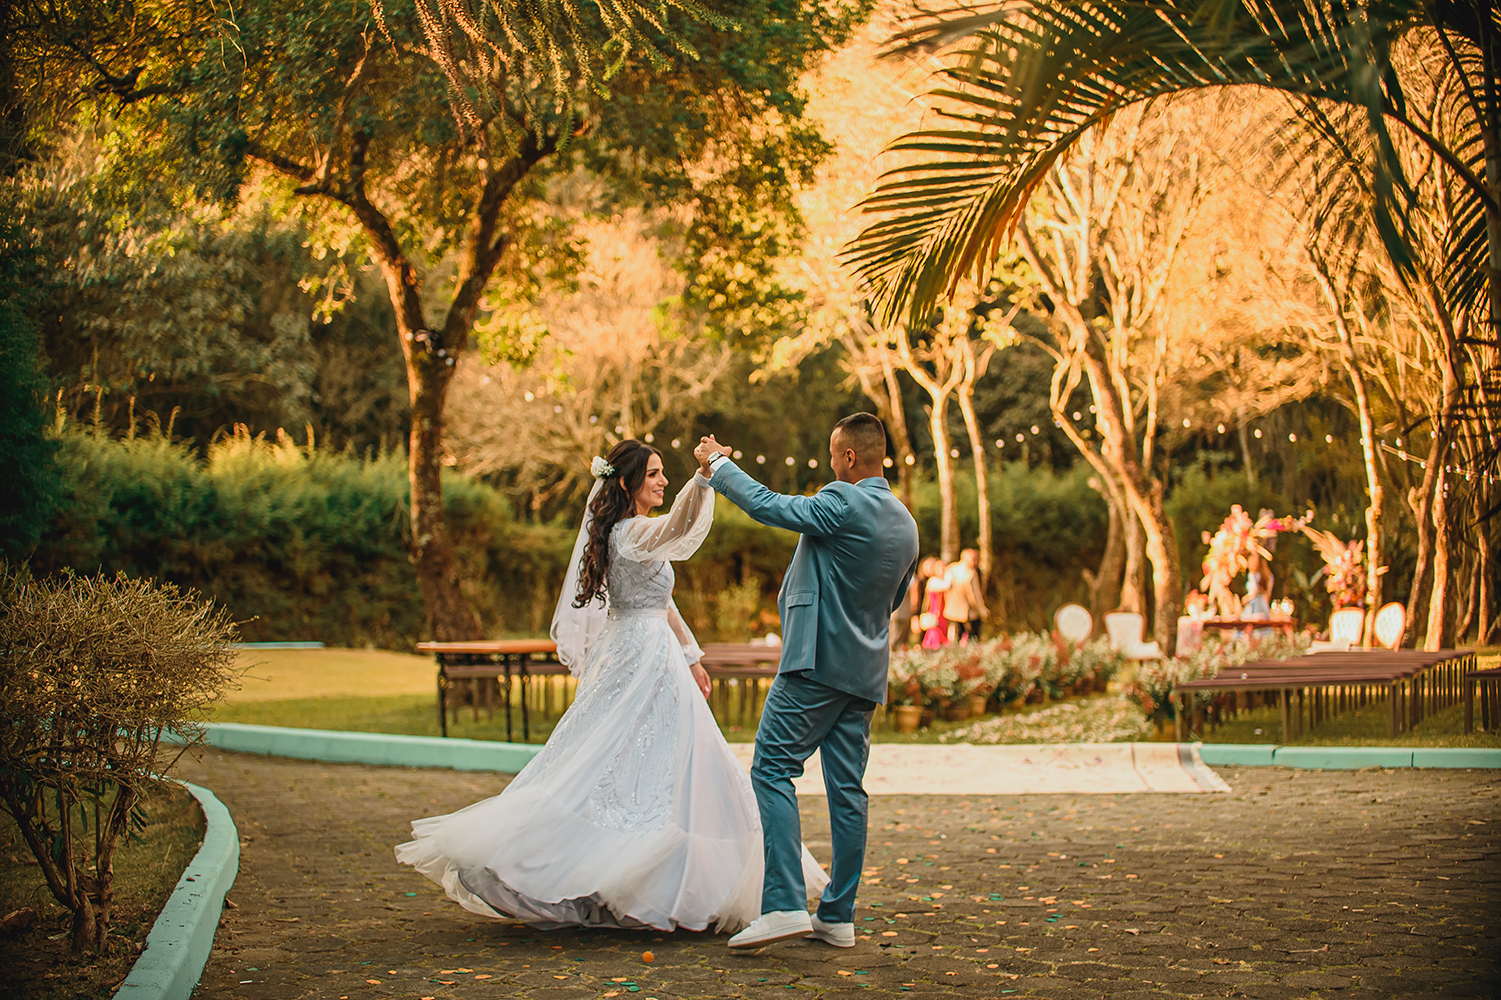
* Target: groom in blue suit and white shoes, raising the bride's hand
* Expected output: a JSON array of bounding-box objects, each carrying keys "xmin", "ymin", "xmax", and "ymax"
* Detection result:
[{"xmin": 693, "ymin": 413, "xmax": 917, "ymax": 947}]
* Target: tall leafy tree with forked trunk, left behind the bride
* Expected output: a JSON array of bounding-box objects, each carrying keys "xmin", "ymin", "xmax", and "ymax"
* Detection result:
[{"xmin": 17, "ymin": 0, "xmax": 868, "ymax": 638}]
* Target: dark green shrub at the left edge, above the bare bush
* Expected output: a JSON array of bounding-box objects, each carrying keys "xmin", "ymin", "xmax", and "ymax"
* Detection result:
[{"xmin": 0, "ymin": 211, "xmax": 60, "ymax": 559}]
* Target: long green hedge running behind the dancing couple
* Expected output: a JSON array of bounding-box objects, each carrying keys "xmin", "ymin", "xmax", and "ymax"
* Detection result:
[{"xmin": 32, "ymin": 429, "xmax": 1105, "ymax": 649}]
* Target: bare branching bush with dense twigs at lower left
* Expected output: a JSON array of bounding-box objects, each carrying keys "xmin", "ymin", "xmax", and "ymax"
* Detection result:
[{"xmin": 0, "ymin": 568, "xmax": 237, "ymax": 952}]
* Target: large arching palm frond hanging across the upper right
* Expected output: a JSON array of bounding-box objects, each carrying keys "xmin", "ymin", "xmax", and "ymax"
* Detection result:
[{"xmin": 847, "ymin": 0, "xmax": 1452, "ymax": 321}]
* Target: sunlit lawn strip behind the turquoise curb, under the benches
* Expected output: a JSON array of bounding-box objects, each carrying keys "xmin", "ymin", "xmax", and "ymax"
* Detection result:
[{"xmin": 210, "ymin": 649, "xmax": 1501, "ymax": 746}]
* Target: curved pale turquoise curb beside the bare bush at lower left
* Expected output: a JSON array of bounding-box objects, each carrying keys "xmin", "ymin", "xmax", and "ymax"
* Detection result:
[{"xmin": 114, "ymin": 781, "xmax": 240, "ymax": 1000}]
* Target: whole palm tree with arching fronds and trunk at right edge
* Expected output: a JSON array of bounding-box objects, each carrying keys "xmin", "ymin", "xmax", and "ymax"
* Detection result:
[{"xmin": 853, "ymin": 0, "xmax": 1501, "ymax": 552}]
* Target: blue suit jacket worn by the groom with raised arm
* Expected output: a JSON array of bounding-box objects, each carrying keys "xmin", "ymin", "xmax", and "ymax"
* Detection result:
[{"xmin": 710, "ymin": 459, "xmax": 917, "ymax": 704}]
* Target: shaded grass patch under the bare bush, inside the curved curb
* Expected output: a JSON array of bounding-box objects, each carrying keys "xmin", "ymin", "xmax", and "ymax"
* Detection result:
[{"xmin": 0, "ymin": 784, "xmax": 203, "ymax": 1000}]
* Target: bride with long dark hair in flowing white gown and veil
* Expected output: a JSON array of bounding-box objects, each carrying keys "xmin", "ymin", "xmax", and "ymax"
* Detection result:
[{"xmin": 396, "ymin": 441, "xmax": 829, "ymax": 931}]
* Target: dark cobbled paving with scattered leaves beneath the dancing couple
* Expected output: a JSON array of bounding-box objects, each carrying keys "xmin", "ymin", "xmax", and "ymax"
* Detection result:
[{"xmin": 180, "ymin": 751, "xmax": 1501, "ymax": 1000}]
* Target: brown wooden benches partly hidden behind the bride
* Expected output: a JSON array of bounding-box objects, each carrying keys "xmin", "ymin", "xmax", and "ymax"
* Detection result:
[{"xmin": 417, "ymin": 640, "xmax": 782, "ymax": 743}]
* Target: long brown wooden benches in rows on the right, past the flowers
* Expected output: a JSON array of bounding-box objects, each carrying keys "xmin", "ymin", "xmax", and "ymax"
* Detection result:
[{"xmin": 1172, "ymin": 649, "xmax": 1475, "ymax": 742}]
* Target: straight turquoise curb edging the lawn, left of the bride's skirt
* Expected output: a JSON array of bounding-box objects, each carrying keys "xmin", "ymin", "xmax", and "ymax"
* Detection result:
[{"xmin": 186, "ymin": 722, "xmax": 542, "ymax": 775}]
